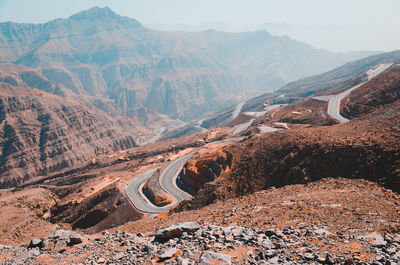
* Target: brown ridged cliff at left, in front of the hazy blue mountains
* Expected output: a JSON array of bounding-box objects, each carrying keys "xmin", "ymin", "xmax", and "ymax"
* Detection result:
[{"xmin": 0, "ymin": 83, "xmax": 139, "ymax": 188}]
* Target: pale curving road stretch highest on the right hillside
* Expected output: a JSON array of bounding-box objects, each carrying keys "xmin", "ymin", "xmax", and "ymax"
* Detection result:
[{"xmin": 327, "ymin": 63, "xmax": 393, "ymax": 123}]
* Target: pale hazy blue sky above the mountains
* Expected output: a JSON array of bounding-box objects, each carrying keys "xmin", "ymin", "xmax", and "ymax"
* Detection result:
[{"xmin": 0, "ymin": 0, "xmax": 400, "ymax": 51}]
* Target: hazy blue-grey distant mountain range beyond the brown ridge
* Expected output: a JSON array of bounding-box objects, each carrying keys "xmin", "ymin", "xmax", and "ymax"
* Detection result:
[{"xmin": 0, "ymin": 8, "xmax": 376, "ymax": 120}]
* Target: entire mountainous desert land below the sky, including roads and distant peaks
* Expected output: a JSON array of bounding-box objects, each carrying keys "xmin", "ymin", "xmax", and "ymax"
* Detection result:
[{"xmin": 0, "ymin": 4, "xmax": 400, "ymax": 265}]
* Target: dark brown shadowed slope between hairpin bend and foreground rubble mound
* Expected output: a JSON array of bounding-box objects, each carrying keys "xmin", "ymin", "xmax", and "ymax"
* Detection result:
[{"xmin": 176, "ymin": 101, "xmax": 400, "ymax": 210}]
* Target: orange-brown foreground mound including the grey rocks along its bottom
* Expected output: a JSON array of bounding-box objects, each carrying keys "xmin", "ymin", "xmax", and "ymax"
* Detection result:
[{"xmin": 0, "ymin": 179, "xmax": 400, "ymax": 265}]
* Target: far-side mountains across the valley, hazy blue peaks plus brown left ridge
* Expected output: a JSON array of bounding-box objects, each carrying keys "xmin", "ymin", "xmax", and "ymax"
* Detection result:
[{"xmin": 0, "ymin": 7, "xmax": 382, "ymax": 186}]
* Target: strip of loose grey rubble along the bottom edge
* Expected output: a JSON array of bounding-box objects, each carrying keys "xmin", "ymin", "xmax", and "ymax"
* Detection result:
[{"xmin": 0, "ymin": 222, "xmax": 400, "ymax": 265}]
